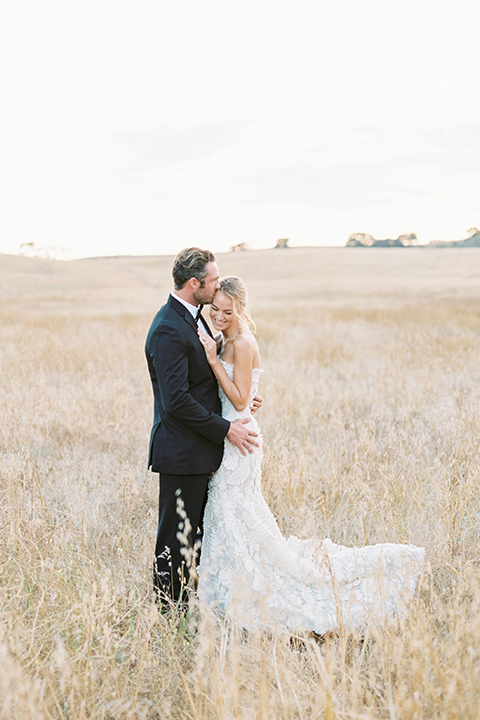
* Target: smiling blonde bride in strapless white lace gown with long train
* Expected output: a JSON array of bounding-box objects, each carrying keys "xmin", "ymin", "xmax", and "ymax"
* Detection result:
[{"xmin": 198, "ymin": 276, "xmax": 424, "ymax": 634}]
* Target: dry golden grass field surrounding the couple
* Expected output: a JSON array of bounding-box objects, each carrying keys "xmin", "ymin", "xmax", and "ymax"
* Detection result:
[{"xmin": 0, "ymin": 248, "xmax": 480, "ymax": 720}]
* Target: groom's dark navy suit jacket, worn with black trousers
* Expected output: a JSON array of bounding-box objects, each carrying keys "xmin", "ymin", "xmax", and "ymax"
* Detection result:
[{"xmin": 145, "ymin": 295, "xmax": 230, "ymax": 475}]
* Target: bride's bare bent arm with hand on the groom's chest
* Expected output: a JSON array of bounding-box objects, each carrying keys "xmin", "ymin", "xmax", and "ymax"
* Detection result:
[{"xmin": 199, "ymin": 333, "xmax": 255, "ymax": 411}]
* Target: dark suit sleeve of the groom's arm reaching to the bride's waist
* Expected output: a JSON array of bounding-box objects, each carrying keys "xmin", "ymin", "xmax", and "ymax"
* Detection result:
[{"xmin": 150, "ymin": 325, "xmax": 230, "ymax": 445}]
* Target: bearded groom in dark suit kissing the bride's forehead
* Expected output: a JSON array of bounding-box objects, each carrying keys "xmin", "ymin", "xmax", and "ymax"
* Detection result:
[{"xmin": 145, "ymin": 247, "xmax": 258, "ymax": 608}]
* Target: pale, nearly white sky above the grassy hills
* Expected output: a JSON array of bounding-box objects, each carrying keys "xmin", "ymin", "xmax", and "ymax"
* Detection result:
[{"xmin": 0, "ymin": 0, "xmax": 480, "ymax": 257}]
